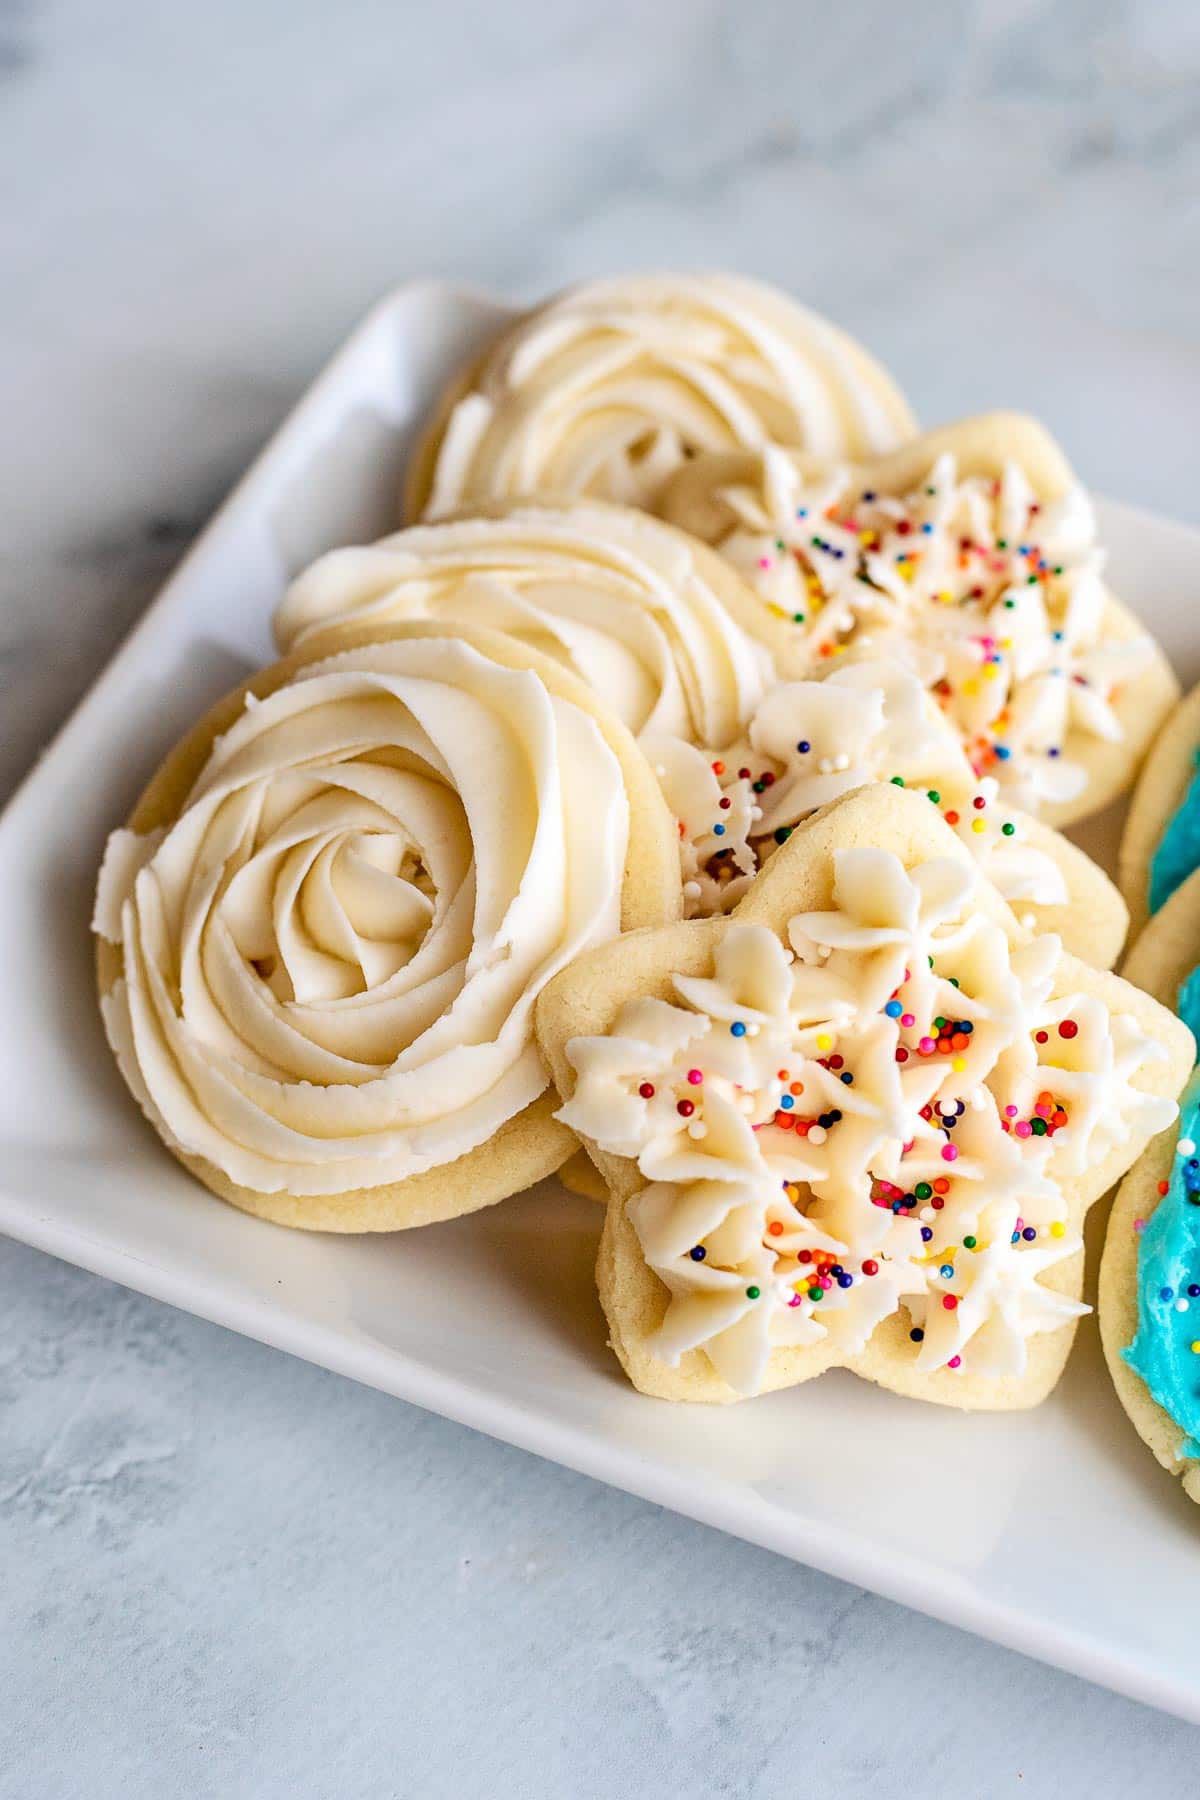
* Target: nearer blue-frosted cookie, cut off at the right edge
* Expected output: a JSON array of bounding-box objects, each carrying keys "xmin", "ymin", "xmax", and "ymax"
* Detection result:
[{"xmin": 1099, "ymin": 824, "xmax": 1200, "ymax": 1501}]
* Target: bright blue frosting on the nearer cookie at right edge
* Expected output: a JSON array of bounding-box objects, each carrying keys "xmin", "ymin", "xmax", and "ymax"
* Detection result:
[{"xmin": 1121, "ymin": 1065, "xmax": 1200, "ymax": 1458}]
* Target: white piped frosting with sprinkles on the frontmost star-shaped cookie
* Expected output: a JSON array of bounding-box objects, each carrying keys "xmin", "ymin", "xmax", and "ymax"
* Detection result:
[{"xmin": 560, "ymin": 848, "xmax": 1177, "ymax": 1393}]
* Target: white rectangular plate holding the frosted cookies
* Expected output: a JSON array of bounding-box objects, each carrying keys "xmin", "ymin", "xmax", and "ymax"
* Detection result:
[{"xmin": 0, "ymin": 284, "xmax": 1200, "ymax": 1721}]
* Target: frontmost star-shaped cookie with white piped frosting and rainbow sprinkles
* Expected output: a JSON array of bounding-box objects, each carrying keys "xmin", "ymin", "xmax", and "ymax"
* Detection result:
[{"xmin": 538, "ymin": 787, "xmax": 1193, "ymax": 1408}]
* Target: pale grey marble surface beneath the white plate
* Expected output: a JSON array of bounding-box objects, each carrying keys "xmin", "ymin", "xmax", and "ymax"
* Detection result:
[{"xmin": 0, "ymin": 0, "xmax": 1200, "ymax": 1800}]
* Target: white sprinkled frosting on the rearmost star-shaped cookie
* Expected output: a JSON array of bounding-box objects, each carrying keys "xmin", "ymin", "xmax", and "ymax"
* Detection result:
[{"xmin": 672, "ymin": 448, "xmax": 1153, "ymax": 812}]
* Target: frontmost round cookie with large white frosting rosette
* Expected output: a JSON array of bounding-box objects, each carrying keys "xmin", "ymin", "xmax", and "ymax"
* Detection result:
[{"xmin": 94, "ymin": 625, "xmax": 680, "ymax": 1231}]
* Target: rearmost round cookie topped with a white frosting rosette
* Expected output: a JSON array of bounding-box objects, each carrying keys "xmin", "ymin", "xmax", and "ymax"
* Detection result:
[{"xmin": 407, "ymin": 274, "xmax": 916, "ymax": 518}]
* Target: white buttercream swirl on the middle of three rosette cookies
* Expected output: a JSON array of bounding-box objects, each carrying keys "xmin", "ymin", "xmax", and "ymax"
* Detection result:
[{"xmin": 273, "ymin": 502, "xmax": 788, "ymax": 913}]
